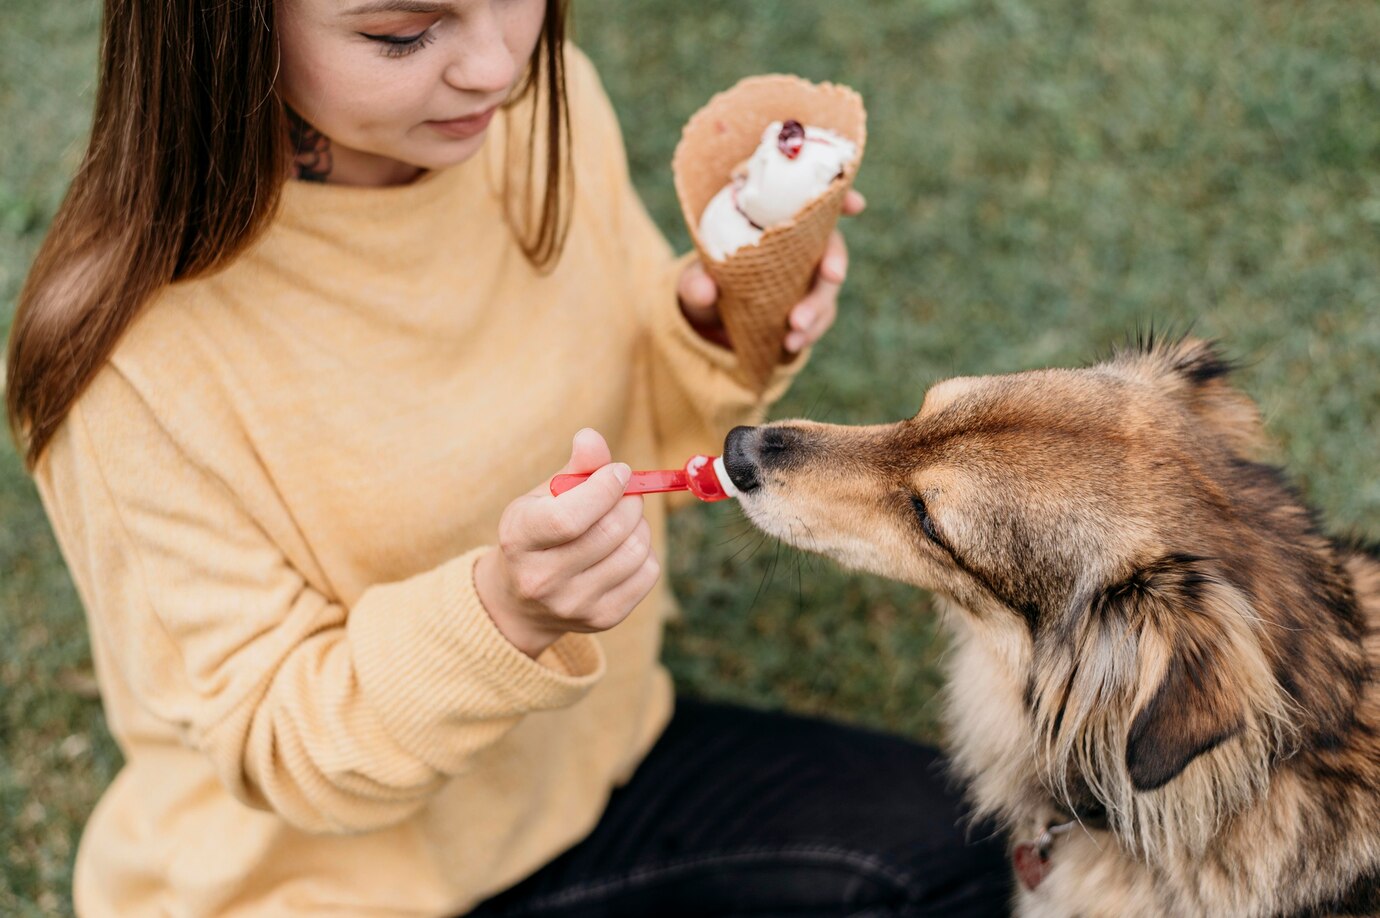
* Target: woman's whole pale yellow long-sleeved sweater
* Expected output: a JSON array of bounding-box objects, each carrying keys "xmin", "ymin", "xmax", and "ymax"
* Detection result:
[{"xmin": 37, "ymin": 52, "xmax": 800, "ymax": 918}]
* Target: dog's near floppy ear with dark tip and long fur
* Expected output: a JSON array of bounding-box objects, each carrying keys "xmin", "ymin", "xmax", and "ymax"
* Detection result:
[{"xmin": 1101, "ymin": 555, "xmax": 1253, "ymax": 791}]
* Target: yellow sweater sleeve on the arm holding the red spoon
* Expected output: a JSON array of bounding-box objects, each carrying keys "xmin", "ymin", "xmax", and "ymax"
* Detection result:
[{"xmin": 39, "ymin": 370, "xmax": 604, "ymax": 832}]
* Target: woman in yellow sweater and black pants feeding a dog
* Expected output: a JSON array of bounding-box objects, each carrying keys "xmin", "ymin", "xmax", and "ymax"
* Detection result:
[{"xmin": 7, "ymin": 0, "xmax": 1003, "ymax": 915}]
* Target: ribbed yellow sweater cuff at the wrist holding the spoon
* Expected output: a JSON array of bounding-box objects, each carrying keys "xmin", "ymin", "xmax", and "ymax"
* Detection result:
[{"xmin": 345, "ymin": 547, "xmax": 604, "ymax": 774}]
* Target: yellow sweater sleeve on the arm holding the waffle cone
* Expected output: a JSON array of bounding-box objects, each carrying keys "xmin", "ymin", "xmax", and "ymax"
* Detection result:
[{"xmin": 573, "ymin": 55, "xmax": 809, "ymax": 465}]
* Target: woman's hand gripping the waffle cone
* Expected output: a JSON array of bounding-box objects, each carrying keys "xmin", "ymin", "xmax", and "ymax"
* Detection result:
[{"xmin": 676, "ymin": 188, "xmax": 867, "ymax": 353}]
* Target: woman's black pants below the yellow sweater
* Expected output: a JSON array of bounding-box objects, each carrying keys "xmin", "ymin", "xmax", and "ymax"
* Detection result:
[{"xmin": 471, "ymin": 699, "xmax": 1012, "ymax": 918}]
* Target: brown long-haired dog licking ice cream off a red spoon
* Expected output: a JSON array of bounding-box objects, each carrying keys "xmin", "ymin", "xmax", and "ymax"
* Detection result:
[{"xmin": 725, "ymin": 335, "xmax": 1380, "ymax": 918}]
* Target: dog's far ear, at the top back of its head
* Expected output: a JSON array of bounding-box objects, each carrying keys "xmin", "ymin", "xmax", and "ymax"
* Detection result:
[{"xmin": 1112, "ymin": 333, "xmax": 1265, "ymax": 458}]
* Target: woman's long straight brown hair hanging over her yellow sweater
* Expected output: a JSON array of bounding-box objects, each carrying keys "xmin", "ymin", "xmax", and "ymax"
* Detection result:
[{"xmin": 6, "ymin": 0, "xmax": 570, "ymax": 469}]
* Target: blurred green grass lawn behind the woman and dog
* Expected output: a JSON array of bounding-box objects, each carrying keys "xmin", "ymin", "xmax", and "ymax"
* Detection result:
[{"xmin": 0, "ymin": 0, "xmax": 1380, "ymax": 915}]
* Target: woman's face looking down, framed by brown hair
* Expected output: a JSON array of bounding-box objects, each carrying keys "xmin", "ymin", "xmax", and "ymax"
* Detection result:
[{"xmin": 276, "ymin": 0, "xmax": 546, "ymax": 185}]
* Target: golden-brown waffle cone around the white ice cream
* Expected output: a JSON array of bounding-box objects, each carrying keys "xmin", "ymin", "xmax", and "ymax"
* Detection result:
[{"xmin": 671, "ymin": 75, "xmax": 867, "ymax": 388}]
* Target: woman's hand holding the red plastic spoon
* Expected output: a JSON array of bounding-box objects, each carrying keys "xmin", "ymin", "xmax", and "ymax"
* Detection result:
[{"xmin": 475, "ymin": 428, "xmax": 661, "ymax": 657}]
